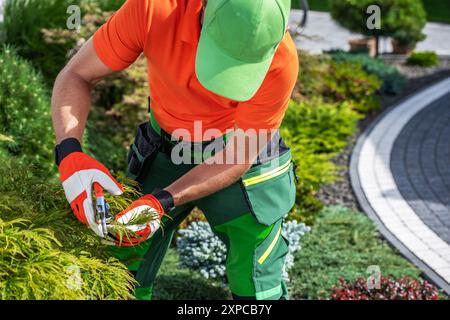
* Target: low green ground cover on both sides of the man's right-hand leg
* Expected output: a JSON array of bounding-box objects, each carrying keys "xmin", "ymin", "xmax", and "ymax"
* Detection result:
[{"xmin": 154, "ymin": 207, "xmax": 421, "ymax": 300}]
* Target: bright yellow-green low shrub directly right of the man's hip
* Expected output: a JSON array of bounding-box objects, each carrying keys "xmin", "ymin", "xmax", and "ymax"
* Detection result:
[{"xmin": 281, "ymin": 99, "xmax": 360, "ymax": 224}]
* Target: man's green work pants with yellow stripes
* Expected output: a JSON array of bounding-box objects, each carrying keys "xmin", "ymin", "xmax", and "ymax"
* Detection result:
[{"xmin": 111, "ymin": 123, "xmax": 295, "ymax": 300}]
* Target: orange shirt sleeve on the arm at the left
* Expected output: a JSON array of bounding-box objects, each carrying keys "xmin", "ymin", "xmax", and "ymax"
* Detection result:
[{"xmin": 93, "ymin": 0, "xmax": 152, "ymax": 71}]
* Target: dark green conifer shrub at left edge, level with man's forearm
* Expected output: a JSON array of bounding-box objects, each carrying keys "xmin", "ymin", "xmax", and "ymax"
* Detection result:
[{"xmin": 0, "ymin": 47, "xmax": 54, "ymax": 172}]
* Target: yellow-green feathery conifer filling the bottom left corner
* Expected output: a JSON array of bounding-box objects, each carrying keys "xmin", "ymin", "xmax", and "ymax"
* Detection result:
[{"xmin": 0, "ymin": 219, "xmax": 134, "ymax": 300}]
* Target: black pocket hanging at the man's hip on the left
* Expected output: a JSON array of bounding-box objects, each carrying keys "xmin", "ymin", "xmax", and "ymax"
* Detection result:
[{"xmin": 127, "ymin": 122, "xmax": 162, "ymax": 182}]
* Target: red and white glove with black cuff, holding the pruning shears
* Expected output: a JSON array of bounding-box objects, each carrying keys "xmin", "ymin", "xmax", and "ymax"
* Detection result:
[{"xmin": 55, "ymin": 138, "xmax": 123, "ymax": 237}]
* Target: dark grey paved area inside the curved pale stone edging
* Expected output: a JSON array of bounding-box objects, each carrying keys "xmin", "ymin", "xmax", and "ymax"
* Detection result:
[{"xmin": 391, "ymin": 94, "xmax": 450, "ymax": 244}]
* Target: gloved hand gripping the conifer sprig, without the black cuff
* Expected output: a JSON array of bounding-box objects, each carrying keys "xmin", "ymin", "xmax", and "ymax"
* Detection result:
[{"xmin": 104, "ymin": 194, "xmax": 165, "ymax": 247}]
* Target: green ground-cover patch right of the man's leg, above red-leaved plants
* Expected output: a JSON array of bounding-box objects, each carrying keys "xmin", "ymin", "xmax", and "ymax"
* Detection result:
[{"xmin": 290, "ymin": 207, "xmax": 421, "ymax": 299}]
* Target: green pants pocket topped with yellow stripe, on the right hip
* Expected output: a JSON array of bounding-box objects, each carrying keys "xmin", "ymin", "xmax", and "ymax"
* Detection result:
[{"xmin": 241, "ymin": 151, "xmax": 296, "ymax": 226}]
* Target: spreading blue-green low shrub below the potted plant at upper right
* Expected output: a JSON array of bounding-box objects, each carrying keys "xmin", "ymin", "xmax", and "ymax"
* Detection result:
[{"xmin": 329, "ymin": 50, "xmax": 406, "ymax": 94}]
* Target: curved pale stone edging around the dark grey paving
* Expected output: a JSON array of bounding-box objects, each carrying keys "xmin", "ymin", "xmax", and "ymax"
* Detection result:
[{"xmin": 350, "ymin": 78, "xmax": 450, "ymax": 294}]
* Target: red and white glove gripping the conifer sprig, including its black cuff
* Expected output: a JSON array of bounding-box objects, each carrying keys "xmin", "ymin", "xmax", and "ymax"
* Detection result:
[{"xmin": 106, "ymin": 190, "xmax": 173, "ymax": 247}]
